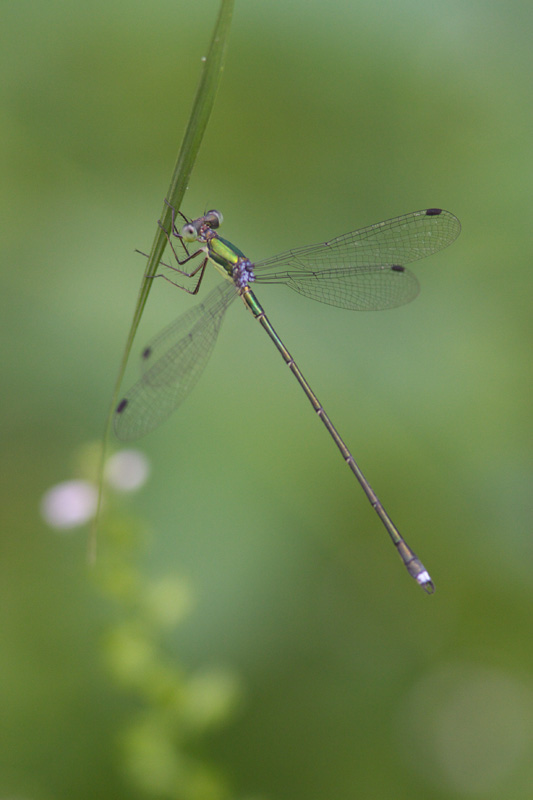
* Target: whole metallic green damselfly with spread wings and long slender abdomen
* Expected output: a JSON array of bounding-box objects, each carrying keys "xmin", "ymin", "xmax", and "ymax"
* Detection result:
[{"xmin": 115, "ymin": 208, "xmax": 461, "ymax": 594}]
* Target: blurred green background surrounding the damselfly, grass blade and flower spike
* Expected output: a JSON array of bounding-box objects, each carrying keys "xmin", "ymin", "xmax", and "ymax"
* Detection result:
[{"xmin": 0, "ymin": 0, "xmax": 533, "ymax": 800}]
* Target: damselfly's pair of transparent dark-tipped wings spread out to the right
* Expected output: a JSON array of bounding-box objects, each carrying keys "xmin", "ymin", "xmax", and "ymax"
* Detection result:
[{"xmin": 254, "ymin": 208, "xmax": 461, "ymax": 311}]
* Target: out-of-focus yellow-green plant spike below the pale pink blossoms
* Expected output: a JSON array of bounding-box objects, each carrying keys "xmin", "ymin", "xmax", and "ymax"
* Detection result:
[{"xmin": 96, "ymin": 495, "xmax": 239, "ymax": 800}]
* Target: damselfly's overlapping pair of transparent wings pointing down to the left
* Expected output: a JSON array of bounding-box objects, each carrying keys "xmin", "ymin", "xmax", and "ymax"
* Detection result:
[{"xmin": 114, "ymin": 282, "xmax": 238, "ymax": 441}]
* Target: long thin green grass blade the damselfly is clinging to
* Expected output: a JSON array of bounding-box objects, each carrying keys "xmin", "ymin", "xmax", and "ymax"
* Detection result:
[{"xmin": 89, "ymin": 0, "xmax": 234, "ymax": 562}]
